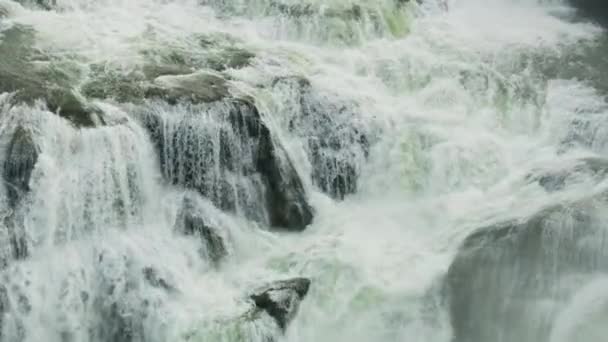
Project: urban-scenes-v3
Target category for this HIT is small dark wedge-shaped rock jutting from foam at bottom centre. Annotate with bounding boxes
[251,278,310,330]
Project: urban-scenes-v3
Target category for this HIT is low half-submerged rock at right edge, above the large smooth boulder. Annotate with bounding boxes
[526,157,608,191]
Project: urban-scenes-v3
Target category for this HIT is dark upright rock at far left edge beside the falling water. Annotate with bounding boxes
[2,126,39,208]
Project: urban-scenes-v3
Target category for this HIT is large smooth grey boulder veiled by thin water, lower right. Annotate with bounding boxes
[445,195,608,342]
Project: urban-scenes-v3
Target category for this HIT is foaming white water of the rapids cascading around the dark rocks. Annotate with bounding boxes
[0,0,608,342]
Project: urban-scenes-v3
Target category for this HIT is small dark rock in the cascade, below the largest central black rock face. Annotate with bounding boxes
[175,197,228,264]
